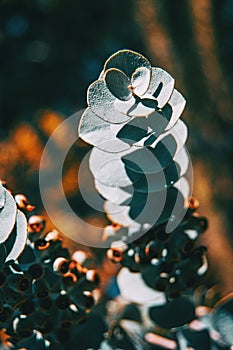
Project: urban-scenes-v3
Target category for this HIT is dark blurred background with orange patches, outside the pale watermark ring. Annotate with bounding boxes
[0,0,233,294]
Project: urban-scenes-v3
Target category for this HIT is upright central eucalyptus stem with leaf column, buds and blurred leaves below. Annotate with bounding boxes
[79,50,233,350]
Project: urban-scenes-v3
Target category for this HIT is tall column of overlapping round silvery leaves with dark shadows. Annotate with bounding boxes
[79,50,192,237]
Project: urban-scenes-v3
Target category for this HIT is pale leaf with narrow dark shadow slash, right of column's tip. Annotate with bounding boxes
[147,67,175,108]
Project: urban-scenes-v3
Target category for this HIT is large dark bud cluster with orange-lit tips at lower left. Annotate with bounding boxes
[0,186,99,349]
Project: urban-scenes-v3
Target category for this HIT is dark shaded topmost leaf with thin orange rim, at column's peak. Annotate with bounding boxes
[104,50,151,79]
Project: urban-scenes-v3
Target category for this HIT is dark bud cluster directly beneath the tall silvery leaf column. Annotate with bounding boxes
[106,198,208,299]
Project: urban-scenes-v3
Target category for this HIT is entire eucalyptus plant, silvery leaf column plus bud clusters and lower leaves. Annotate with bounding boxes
[0,50,233,350]
